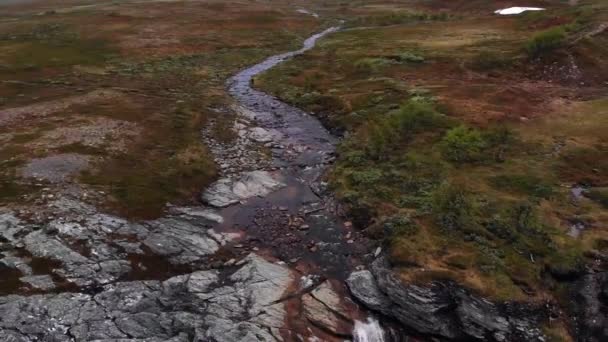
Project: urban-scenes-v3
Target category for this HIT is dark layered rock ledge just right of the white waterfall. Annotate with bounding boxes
[347,258,543,341]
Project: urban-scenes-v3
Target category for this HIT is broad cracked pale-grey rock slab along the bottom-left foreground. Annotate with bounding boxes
[0,254,293,342]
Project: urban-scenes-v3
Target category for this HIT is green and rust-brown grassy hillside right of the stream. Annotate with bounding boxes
[256,1,608,312]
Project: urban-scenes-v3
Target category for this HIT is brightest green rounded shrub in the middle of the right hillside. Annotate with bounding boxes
[441,125,487,163]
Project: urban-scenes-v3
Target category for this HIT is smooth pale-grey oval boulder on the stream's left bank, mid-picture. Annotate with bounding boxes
[202,171,285,208]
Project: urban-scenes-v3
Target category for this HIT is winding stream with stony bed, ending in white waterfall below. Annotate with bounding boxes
[216,27,384,342]
